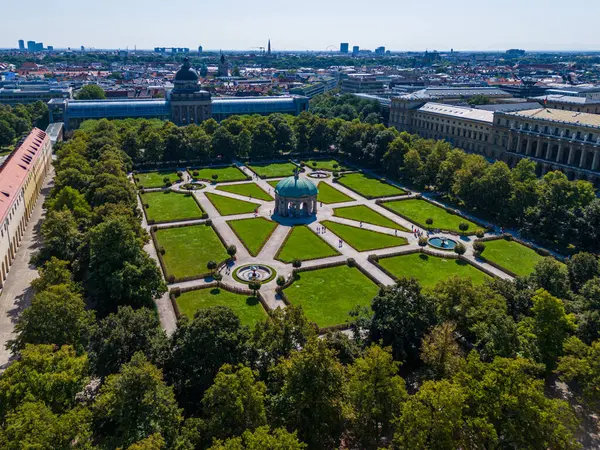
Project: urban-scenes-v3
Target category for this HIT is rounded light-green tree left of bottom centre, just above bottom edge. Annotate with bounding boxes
[202,364,267,439]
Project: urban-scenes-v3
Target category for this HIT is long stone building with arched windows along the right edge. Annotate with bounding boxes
[390,99,600,187]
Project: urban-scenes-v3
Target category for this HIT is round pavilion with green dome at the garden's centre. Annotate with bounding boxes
[275,171,319,217]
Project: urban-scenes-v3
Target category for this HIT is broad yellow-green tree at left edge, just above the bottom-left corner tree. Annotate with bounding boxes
[0,345,88,418]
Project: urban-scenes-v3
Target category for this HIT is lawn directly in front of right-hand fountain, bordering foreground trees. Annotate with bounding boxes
[379,253,489,288]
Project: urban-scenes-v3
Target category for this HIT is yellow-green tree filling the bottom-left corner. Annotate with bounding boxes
[0,401,95,450]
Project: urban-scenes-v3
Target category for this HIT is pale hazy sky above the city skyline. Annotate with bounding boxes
[0,0,600,50]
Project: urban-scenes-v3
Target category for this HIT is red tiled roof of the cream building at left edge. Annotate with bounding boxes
[0,128,50,223]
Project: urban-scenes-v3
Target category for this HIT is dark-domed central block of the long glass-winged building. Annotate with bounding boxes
[169,58,212,125]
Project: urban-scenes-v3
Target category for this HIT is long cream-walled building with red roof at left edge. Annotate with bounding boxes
[0,128,52,288]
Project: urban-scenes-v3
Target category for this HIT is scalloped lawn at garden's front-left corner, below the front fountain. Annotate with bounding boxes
[177,288,267,327]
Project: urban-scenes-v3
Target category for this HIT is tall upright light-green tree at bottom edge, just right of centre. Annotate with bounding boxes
[348,345,407,449]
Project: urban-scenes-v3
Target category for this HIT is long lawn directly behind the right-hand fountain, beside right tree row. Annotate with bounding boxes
[384,198,479,233]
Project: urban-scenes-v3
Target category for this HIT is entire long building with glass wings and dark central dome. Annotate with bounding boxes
[48,58,308,130]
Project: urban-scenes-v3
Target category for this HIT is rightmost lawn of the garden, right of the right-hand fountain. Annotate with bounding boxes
[482,239,544,277]
